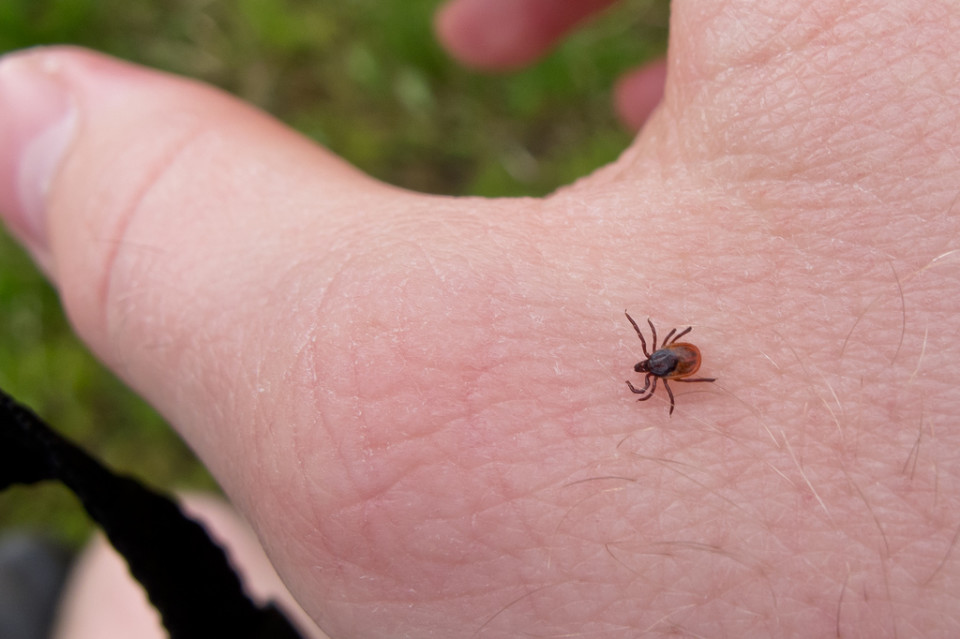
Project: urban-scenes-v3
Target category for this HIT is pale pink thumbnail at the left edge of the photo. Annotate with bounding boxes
[0,49,77,247]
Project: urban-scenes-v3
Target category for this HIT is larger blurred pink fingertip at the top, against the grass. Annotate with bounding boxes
[436,0,615,70]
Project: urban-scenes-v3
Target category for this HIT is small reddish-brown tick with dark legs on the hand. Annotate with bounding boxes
[623,311,717,415]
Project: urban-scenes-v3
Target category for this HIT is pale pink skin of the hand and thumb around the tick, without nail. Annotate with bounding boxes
[5,0,960,639]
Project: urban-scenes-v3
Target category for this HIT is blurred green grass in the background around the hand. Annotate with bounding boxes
[0,0,668,544]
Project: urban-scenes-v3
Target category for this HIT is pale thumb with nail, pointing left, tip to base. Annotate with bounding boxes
[0,48,402,464]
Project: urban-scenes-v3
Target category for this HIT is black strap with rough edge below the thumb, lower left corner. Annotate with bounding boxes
[0,390,301,639]
